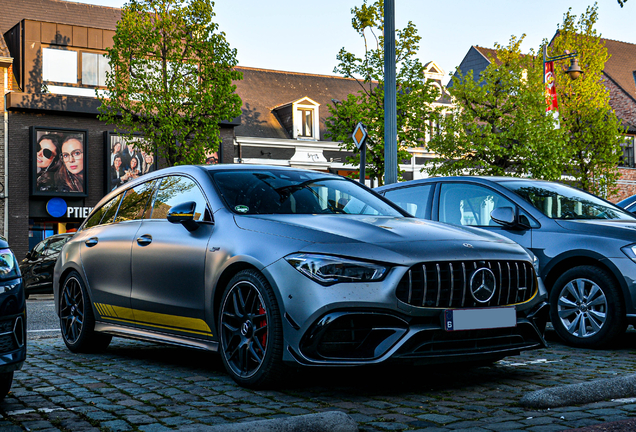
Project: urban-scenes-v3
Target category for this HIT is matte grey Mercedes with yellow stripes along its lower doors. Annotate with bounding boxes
[54,165,547,387]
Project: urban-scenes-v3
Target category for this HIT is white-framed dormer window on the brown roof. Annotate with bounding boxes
[273,97,320,140]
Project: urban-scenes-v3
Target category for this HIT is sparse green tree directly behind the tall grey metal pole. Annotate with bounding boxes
[326,0,439,184]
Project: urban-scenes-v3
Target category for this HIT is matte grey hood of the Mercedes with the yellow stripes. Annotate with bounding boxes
[235,215,530,263]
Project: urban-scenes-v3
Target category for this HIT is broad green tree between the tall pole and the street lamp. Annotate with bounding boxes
[426,35,566,179]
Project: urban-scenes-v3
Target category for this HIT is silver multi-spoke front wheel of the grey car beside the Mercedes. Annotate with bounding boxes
[550,266,626,348]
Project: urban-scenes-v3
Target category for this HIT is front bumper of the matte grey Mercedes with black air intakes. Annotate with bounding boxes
[266,260,548,366]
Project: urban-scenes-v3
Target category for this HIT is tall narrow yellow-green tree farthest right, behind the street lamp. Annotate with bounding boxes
[550,4,624,196]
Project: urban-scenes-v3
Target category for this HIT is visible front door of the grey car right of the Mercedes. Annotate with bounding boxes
[434,182,536,249]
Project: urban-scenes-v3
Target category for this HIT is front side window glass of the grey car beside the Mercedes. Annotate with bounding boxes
[439,183,516,226]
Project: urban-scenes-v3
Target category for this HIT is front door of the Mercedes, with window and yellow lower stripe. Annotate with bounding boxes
[131,175,214,337]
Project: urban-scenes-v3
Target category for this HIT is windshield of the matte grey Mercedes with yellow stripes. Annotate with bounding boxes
[210,170,403,216]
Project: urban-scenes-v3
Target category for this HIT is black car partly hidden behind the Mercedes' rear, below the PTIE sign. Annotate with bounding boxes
[20,233,73,298]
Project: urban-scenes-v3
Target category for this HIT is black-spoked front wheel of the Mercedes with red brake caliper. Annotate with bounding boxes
[219,270,284,388]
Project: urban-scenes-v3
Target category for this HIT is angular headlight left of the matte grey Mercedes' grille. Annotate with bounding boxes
[285,254,388,285]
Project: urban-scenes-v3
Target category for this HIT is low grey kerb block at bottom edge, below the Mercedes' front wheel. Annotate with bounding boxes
[181,411,358,432]
